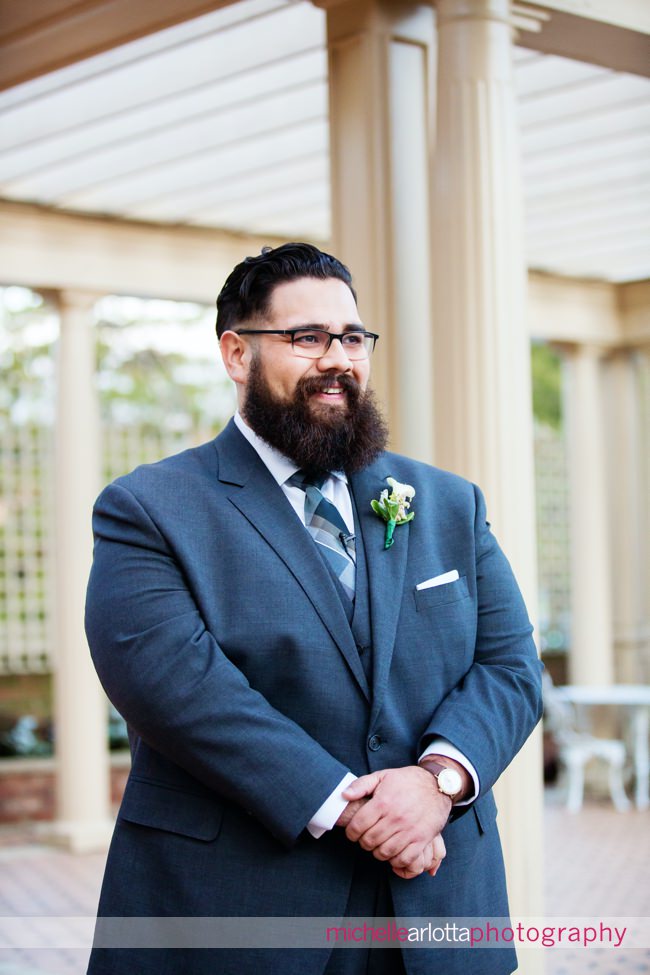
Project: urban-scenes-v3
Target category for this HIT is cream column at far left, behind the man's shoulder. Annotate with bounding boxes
[54,291,111,852]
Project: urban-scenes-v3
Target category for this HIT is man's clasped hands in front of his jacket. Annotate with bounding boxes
[336,765,452,880]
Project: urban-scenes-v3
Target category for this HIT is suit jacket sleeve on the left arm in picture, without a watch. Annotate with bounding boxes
[86,483,348,845]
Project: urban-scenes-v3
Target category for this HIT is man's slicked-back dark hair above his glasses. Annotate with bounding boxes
[217,244,357,338]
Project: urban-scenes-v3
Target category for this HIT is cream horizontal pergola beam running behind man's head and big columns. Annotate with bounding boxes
[0,200,650,348]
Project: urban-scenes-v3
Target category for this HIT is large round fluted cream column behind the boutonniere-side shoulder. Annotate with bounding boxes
[433,0,542,944]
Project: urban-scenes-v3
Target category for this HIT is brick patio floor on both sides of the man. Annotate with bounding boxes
[0,793,650,975]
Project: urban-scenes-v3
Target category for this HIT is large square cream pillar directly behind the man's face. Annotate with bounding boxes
[321,0,434,462]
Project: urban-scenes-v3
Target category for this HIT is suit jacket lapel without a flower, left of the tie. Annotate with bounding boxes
[215,421,370,699]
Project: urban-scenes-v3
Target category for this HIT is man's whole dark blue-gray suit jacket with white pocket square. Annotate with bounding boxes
[86,422,541,975]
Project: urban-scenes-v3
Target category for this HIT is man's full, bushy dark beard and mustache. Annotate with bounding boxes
[242,356,388,474]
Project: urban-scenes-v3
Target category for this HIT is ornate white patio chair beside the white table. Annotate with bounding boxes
[543,674,630,812]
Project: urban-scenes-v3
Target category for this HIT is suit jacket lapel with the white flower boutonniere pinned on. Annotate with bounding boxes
[350,458,411,720]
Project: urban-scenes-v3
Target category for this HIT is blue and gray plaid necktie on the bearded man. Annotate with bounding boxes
[287,471,356,601]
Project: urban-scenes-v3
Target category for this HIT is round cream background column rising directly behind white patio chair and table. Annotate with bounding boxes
[565,345,614,684]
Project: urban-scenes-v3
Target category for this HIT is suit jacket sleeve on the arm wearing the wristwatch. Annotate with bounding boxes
[420,487,543,795]
